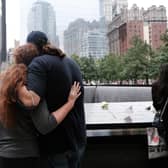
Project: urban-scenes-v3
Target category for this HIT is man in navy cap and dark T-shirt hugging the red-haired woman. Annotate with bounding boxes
[19,31,86,168]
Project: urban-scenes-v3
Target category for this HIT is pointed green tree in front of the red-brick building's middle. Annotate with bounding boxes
[123,36,150,84]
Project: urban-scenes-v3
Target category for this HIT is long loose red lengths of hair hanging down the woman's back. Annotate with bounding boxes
[0,64,27,127]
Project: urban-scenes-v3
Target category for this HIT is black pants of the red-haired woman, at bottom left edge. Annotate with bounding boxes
[0,157,47,168]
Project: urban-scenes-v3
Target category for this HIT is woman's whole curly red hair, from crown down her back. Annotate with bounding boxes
[0,43,39,127]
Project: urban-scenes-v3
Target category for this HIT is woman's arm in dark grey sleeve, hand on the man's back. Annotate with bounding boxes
[31,82,81,135]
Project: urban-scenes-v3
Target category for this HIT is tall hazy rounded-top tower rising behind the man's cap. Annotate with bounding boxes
[27,1,58,45]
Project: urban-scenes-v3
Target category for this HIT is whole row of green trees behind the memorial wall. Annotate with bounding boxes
[72,31,168,84]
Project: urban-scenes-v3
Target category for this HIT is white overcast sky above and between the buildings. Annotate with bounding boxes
[6,0,168,48]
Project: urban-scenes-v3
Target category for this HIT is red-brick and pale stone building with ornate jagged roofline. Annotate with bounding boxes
[108,4,167,54]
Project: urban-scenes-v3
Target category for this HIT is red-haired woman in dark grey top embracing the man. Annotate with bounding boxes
[0,44,81,168]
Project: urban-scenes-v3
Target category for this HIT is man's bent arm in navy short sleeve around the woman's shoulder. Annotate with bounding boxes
[17,57,48,107]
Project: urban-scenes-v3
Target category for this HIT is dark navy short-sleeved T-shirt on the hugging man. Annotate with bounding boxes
[27,55,86,154]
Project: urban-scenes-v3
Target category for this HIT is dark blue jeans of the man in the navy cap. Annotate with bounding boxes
[48,147,85,168]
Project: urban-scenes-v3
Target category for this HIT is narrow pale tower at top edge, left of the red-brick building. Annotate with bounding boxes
[99,0,112,22]
